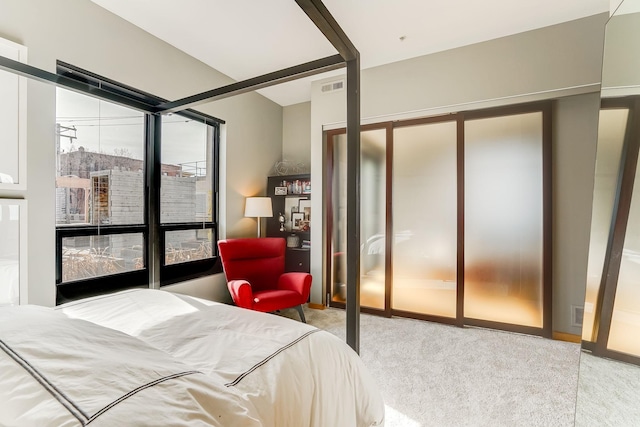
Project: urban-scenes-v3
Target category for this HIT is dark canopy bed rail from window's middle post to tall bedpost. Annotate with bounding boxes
[155,55,345,113]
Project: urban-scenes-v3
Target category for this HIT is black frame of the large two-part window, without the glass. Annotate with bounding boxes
[55,61,225,304]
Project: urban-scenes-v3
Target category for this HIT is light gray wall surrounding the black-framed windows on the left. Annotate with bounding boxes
[0,0,282,305]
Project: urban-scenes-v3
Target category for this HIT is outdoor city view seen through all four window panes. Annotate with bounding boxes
[56,89,213,282]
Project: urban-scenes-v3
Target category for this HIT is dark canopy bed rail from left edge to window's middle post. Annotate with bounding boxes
[0,56,154,112]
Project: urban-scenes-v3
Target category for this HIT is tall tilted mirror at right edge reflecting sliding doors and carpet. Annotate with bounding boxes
[575,0,640,427]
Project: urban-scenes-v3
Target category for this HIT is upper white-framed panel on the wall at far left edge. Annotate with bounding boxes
[0,38,27,190]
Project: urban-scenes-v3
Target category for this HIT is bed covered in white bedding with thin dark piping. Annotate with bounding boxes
[0,289,384,427]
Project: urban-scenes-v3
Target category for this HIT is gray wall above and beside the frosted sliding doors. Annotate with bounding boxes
[304,13,608,333]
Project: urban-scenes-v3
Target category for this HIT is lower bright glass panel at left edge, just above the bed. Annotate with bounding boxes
[0,200,20,306]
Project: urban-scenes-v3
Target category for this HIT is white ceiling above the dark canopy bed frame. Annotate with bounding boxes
[92,0,610,106]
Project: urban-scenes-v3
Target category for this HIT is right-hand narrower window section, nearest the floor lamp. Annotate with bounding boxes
[160,114,217,284]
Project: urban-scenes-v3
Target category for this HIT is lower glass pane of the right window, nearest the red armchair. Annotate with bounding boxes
[164,229,213,265]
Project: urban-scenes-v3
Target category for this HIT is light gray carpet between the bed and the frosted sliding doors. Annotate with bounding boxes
[281,308,580,427]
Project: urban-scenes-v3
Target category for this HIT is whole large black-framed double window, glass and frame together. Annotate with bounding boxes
[55,64,219,302]
